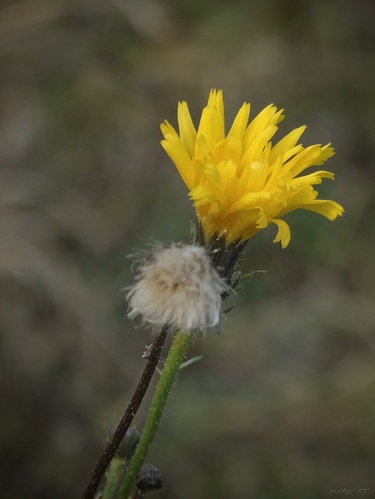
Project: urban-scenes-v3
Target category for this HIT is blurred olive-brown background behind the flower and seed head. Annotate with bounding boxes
[0,0,375,499]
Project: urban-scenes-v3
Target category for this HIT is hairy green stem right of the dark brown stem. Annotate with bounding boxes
[117,333,193,499]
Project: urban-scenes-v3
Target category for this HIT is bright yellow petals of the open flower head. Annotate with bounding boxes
[161,90,344,248]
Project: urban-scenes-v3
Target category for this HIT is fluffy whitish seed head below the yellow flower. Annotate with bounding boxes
[126,244,229,332]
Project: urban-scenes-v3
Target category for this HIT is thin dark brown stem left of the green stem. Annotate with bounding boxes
[81,326,168,499]
